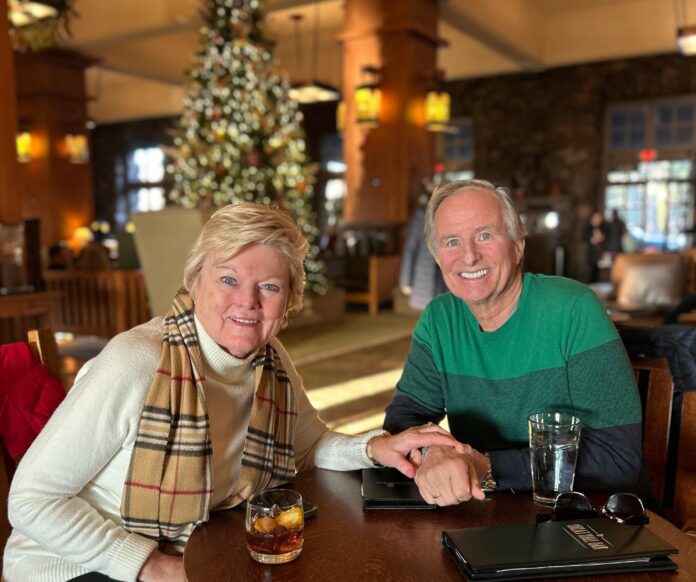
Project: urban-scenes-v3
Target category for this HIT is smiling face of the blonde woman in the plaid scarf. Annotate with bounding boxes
[194,244,290,358]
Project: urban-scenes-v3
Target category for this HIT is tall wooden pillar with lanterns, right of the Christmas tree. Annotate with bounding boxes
[341,0,438,224]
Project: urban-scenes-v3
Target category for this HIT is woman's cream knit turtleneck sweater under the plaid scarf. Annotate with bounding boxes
[2,318,382,582]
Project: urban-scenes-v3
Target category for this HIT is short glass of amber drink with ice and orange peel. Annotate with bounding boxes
[246,489,304,564]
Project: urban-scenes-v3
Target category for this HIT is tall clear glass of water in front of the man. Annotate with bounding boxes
[528,412,581,507]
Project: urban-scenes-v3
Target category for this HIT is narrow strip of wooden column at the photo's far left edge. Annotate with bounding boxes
[0,0,22,223]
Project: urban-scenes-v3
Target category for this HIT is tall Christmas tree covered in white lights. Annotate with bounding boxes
[167,0,326,293]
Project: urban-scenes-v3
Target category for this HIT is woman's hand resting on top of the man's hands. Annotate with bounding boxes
[371,422,464,478]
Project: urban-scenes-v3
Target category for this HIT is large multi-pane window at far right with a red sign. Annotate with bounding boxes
[604,96,696,250]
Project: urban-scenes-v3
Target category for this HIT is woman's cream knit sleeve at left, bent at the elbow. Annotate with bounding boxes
[4,324,159,582]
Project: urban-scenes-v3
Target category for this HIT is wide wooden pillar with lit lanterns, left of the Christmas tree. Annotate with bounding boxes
[15,49,94,247]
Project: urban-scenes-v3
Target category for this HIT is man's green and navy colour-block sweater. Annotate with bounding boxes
[384,273,641,490]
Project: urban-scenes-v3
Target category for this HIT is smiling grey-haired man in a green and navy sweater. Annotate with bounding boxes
[384,180,641,505]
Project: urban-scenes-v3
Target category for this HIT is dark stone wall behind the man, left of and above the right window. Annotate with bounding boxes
[448,54,696,279]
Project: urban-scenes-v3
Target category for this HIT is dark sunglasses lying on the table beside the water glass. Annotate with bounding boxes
[537,491,650,525]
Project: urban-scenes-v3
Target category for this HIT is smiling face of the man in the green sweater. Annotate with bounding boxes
[434,189,524,310]
